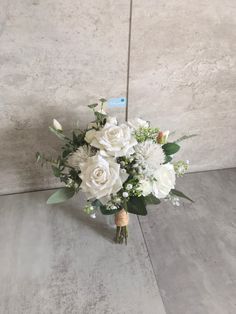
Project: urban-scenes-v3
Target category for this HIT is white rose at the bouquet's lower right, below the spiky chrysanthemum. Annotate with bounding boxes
[152,164,175,198]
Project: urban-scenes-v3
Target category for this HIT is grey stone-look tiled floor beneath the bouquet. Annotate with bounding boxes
[0,169,236,314]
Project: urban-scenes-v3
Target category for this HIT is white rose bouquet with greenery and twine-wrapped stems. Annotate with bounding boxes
[36,99,193,244]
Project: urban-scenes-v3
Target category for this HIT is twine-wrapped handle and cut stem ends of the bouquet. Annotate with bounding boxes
[115,208,129,244]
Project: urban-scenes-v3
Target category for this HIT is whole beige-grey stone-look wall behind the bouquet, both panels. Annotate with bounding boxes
[0,0,236,193]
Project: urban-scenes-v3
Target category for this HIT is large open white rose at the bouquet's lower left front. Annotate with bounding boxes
[80,154,122,199]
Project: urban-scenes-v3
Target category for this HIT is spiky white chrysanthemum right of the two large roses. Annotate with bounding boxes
[135,140,165,171]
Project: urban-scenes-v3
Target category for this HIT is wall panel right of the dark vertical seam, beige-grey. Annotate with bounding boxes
[129,0,236,171]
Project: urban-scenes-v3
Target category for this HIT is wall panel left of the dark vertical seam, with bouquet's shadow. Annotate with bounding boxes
[0,0,129,193]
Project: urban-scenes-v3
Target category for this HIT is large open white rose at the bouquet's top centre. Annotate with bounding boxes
[91,123,137,157]
